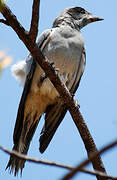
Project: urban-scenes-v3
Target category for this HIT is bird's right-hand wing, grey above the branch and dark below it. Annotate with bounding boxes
[39,49,86,153]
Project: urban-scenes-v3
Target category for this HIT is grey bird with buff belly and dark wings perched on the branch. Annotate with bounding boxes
[6,6,103,176]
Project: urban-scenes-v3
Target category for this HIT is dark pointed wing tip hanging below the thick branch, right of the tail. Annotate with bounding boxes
[39,103,67,153]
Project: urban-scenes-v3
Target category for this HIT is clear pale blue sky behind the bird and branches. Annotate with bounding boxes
[0,0,117,180]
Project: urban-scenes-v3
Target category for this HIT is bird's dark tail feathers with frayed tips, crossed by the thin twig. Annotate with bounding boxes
[6,115,39,176]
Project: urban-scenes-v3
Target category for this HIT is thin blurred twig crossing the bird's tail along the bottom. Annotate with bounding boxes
[0,146,117,180]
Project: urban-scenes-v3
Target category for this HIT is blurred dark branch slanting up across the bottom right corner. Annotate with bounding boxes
[62,140,117,180]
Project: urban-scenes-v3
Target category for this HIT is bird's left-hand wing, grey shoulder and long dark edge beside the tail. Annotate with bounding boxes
[13,30,51,143]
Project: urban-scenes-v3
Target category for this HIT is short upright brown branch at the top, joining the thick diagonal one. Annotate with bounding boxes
[29,0,40,42]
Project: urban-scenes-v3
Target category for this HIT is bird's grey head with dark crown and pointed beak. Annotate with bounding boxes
[53,7,103,29]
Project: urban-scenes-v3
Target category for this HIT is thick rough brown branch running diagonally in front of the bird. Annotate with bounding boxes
[0,0,107,180]
